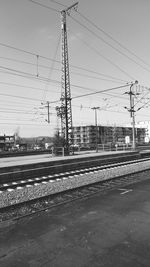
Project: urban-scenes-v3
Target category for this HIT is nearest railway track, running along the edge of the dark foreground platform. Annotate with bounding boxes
[0,170,150,222]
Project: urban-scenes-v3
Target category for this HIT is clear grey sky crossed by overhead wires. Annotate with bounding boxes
[0,0,150,137]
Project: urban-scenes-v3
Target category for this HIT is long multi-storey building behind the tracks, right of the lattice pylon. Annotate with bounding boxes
[73,125,146,148]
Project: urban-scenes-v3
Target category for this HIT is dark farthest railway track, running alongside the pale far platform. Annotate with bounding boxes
[0,152,141,184]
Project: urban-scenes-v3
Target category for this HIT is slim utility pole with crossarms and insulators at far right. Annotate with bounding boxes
[125,81,138,150]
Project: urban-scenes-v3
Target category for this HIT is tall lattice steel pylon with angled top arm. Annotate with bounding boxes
[61,2,78,154]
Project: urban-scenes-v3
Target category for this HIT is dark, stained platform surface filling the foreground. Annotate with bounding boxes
[0,177,150,267]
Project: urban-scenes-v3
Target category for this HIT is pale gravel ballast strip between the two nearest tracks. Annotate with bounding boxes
[0,160,150,208]
